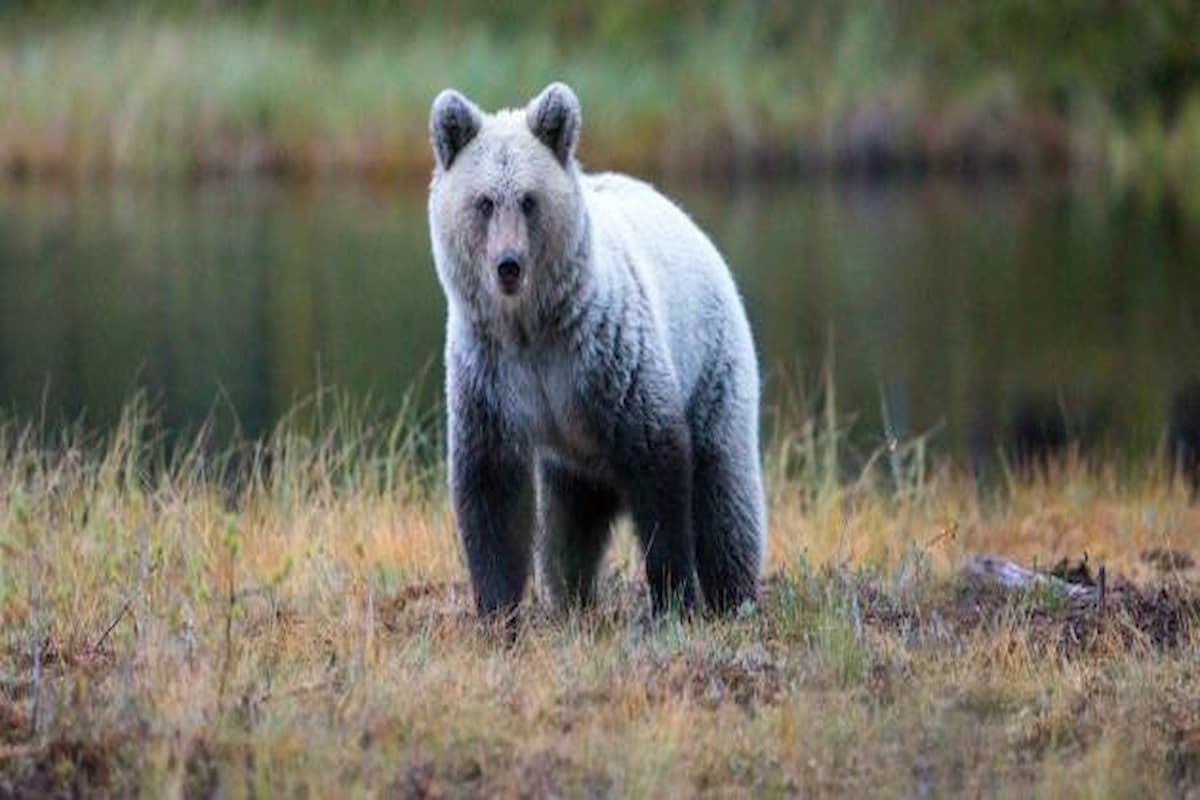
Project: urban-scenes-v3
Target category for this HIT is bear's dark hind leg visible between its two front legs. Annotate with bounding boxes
[538,461,620,610]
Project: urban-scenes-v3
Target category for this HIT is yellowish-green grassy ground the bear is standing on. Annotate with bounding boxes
[0,407,1200,796]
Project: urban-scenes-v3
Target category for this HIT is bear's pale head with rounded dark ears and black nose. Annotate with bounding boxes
[430,83,587,328]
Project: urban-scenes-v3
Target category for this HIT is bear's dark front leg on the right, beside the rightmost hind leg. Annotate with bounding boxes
[619,414,696,614]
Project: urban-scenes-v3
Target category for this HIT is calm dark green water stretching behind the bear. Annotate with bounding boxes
[0,182,1200,456]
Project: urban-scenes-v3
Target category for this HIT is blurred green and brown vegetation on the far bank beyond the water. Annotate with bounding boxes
[0,0,1200,180]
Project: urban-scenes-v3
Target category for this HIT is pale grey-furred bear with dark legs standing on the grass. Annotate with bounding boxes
[428,83,767,621]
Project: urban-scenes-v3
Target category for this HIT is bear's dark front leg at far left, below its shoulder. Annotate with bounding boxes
[449,357,535,624]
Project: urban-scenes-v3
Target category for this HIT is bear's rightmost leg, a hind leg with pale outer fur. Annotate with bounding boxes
[692,407,766,614]
